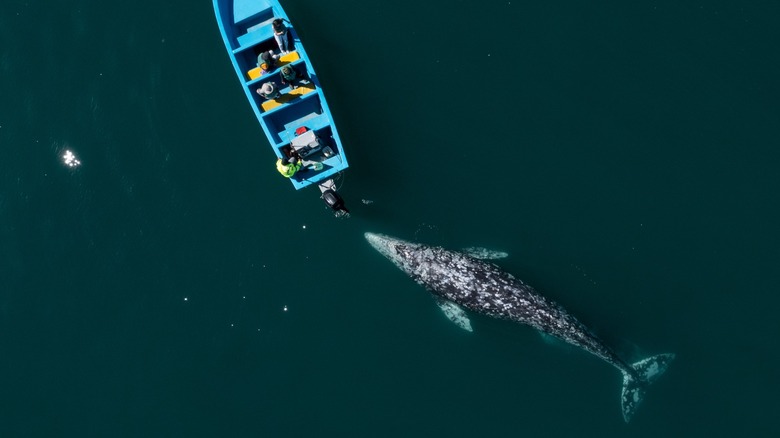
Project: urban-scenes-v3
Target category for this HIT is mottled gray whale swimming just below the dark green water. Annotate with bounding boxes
[365,233,674,422]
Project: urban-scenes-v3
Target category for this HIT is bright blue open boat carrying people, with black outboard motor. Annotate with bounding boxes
[213,0,348,215]
